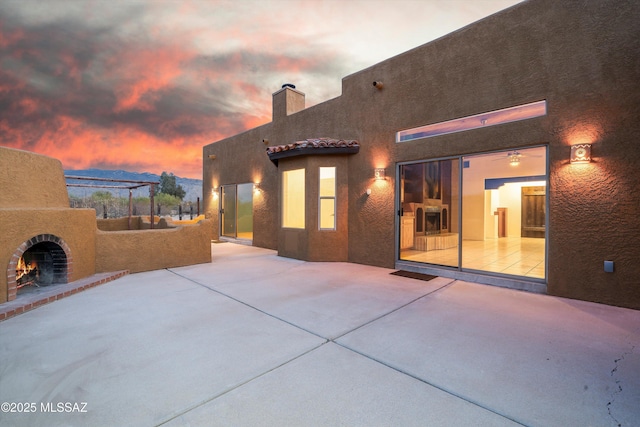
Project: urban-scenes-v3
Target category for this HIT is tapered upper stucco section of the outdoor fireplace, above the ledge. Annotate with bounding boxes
[0,147,69,209]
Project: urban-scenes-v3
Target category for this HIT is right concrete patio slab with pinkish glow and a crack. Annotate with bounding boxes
[337,281,640,426]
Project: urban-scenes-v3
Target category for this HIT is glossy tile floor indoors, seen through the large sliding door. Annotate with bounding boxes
[400,237,545,279]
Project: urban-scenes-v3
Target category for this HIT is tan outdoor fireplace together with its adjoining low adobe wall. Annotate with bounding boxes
[0,147,213,308]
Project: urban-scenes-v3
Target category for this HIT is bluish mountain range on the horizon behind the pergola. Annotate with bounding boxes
[64,169,202,203]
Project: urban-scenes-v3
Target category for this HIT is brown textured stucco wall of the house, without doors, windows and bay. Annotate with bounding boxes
[204,0,640,308]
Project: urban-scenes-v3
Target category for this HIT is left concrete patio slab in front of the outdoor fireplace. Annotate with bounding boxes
[0,270,324,426]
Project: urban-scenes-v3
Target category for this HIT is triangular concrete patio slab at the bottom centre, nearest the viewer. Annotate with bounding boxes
[166,343,519,427]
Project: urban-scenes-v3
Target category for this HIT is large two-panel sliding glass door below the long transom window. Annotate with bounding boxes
[399,147,547,279]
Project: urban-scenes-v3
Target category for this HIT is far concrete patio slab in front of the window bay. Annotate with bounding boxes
[175,244,453,339]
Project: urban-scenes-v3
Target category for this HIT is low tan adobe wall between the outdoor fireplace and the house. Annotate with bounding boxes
[95,220,212,273]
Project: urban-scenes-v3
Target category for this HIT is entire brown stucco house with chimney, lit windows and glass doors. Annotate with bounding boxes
[203,0,640,309]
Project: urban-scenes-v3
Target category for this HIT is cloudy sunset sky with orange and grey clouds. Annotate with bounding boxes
[0,0,519,179]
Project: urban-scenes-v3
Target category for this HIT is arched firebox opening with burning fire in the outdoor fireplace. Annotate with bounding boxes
[16,242,67,293]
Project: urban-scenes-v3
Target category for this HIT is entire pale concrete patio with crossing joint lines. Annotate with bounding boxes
[0,243,640,426]
